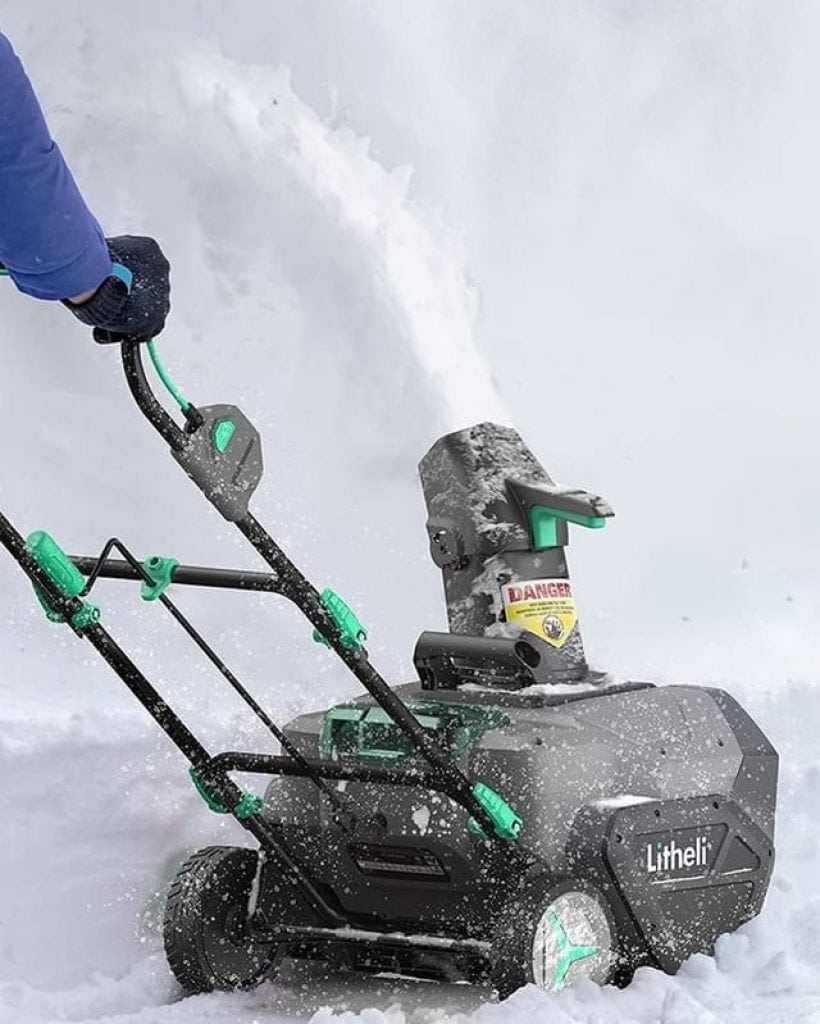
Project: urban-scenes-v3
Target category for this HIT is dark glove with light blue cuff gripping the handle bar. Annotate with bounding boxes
[63,234,171,345]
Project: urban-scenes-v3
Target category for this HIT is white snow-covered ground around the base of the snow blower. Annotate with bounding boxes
[0,686,820,1024]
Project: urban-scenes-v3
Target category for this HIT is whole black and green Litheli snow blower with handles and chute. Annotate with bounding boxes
[0,343,778,996]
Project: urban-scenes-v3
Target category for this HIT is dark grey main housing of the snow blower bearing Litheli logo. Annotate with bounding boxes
[259,684,777,975]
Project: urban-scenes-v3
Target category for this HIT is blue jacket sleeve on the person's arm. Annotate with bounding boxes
[0,34,112,299]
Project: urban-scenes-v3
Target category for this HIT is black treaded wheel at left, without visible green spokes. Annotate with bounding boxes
[163,846,276,994]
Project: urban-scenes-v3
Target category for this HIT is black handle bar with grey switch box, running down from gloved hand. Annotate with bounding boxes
[121,342,522,842]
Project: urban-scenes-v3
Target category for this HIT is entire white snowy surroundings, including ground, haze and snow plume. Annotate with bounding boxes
[0,0,820,1024]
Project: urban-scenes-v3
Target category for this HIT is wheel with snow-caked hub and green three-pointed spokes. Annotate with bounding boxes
[490,878,617,999]
